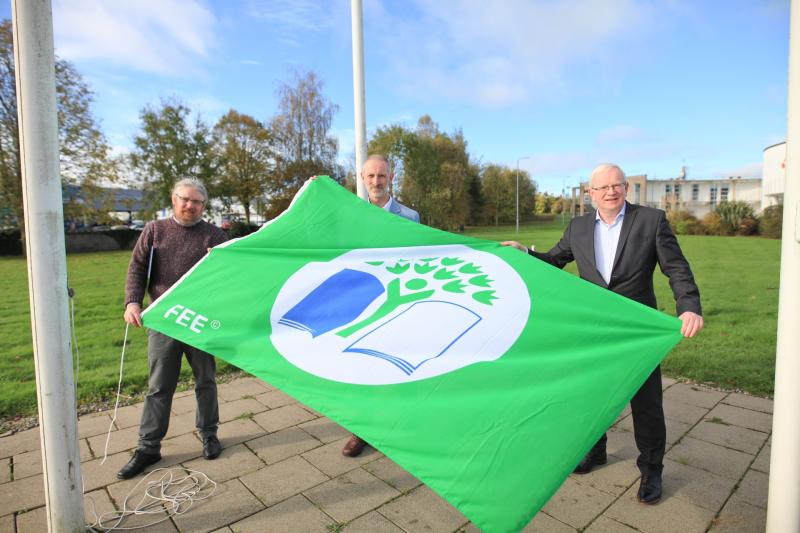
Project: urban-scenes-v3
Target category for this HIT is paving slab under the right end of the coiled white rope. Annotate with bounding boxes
[172,479,264,533]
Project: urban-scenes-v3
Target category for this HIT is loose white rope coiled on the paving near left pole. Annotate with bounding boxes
[89,468,217,532]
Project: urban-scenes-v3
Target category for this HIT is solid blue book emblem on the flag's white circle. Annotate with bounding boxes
[278,268,384,337]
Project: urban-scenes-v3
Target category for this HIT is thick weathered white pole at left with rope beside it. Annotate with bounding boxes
[12,0,86,532]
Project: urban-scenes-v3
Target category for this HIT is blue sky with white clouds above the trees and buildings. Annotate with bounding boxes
[0,0,789,192]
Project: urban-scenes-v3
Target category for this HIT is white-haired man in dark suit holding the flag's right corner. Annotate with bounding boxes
[503,164,703,504]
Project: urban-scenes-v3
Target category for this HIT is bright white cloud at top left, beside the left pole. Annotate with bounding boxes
[53,0,216,75]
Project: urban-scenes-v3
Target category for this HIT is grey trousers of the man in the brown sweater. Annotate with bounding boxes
[138,330,219,453]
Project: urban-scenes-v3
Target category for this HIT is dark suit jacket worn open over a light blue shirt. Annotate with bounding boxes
[531,204,701,316]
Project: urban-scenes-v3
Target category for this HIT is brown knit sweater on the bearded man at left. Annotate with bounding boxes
[125,218,228,305]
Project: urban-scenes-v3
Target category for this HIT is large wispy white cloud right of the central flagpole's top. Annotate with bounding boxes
[365,0,653,107]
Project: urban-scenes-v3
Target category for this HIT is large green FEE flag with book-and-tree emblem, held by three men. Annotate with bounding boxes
[144,177,681,532]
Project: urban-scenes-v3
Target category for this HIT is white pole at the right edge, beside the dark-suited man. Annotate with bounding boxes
[767,0,800,533]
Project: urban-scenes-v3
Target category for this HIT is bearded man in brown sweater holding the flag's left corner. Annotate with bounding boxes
[117,179,228,479]
